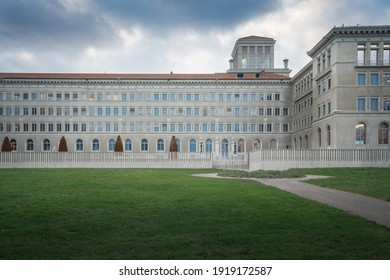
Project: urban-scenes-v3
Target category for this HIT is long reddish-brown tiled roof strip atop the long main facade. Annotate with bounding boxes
[0,72,290,80]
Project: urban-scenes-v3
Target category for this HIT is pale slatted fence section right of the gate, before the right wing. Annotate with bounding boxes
[248,149,390,171]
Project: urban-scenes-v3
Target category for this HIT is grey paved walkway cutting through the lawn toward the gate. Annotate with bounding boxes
[196,173,390,228]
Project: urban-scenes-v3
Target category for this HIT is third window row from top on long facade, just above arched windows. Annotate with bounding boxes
[0,122,289,133]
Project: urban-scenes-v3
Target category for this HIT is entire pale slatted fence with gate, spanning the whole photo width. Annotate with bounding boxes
[0,149,390,171]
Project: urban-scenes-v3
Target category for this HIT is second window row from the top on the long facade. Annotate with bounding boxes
[0,106,289,117]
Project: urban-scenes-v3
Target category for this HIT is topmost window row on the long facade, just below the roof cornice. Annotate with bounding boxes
[0,92,281,102]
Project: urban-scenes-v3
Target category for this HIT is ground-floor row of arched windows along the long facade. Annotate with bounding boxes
[2,138,277,154]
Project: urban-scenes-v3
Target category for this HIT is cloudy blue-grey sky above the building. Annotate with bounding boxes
[0,0,390,73]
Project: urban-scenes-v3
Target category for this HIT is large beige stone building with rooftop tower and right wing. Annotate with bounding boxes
[0,26,390,155]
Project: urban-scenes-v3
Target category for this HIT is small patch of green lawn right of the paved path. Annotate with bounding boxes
[303,168,390,201]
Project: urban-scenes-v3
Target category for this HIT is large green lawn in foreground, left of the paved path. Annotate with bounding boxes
[0,169,390,259]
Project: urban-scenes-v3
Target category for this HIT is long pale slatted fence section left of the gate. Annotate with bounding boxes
[0,152,212,168]
